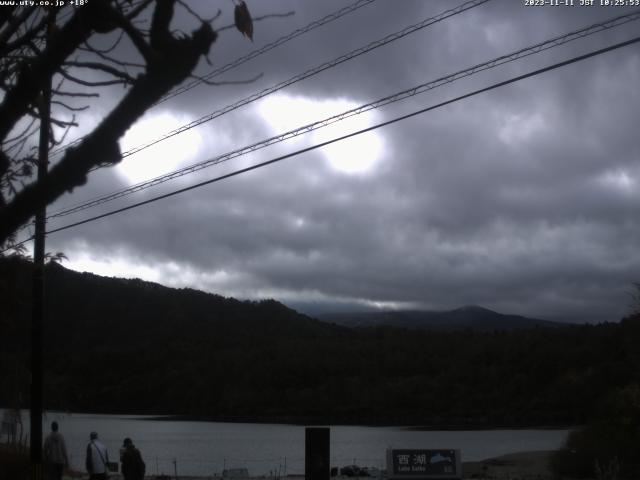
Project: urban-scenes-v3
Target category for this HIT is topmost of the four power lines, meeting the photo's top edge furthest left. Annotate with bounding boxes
[51,0,376,155]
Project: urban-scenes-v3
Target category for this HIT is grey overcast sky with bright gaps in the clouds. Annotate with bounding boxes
[31,0,640,322]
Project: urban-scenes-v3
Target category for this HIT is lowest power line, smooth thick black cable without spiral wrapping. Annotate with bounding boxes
[32,36,640,244]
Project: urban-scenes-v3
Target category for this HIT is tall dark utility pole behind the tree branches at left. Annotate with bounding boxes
[30,10,55,480]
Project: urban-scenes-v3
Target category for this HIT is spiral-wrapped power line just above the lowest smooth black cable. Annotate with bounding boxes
[48,10,640,219]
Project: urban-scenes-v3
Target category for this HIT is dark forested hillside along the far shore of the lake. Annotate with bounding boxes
[0,260,640,427]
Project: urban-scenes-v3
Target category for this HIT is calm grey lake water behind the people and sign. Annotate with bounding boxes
[2,412,567,475]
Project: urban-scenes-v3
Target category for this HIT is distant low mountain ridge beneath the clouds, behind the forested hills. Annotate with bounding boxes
[317,305,567,331]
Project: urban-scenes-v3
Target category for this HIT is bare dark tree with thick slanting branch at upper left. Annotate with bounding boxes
[0,0,255,246]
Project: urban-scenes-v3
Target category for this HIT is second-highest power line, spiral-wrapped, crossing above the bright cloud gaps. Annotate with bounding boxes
[48,0,490,162]
